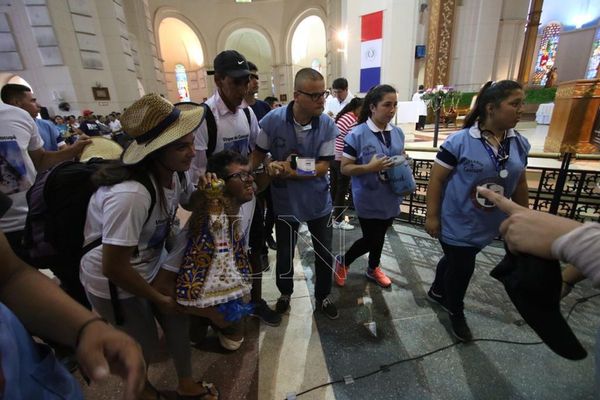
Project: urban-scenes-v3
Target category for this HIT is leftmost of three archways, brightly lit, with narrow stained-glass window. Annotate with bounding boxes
[158,17,208,103]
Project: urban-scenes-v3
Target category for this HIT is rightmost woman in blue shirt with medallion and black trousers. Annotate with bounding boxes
[425,80,530,341]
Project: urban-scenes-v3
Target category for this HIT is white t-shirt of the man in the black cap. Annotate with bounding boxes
[190,91,259,182]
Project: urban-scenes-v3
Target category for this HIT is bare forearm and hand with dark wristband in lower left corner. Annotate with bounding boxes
[0,233,146,400]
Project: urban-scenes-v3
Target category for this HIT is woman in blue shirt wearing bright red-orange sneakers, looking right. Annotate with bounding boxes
[334,85,404,288]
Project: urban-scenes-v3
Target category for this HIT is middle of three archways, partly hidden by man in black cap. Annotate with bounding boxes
[225,28,273,99]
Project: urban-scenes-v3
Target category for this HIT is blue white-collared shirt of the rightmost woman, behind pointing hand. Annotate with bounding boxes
[435,126,531,248]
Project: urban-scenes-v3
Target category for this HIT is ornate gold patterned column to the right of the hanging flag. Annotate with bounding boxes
[425,0,456,87]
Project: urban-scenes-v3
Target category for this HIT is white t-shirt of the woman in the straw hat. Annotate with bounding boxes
[80,174,194,299]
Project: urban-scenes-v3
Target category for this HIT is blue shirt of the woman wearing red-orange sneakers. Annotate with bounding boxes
[343,119,404,219]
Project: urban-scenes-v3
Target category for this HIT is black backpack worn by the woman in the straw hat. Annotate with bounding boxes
[24,158,156,269]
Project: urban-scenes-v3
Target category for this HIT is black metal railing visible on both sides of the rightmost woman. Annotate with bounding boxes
[398,148,600,225]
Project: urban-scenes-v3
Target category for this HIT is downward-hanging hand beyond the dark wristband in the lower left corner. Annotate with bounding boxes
[77,321,146,400]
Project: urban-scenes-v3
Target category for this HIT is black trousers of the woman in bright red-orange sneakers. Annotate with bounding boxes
[342,217,394,269]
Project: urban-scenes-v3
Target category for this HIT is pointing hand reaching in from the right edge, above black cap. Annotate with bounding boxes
[477,187,581,259]
